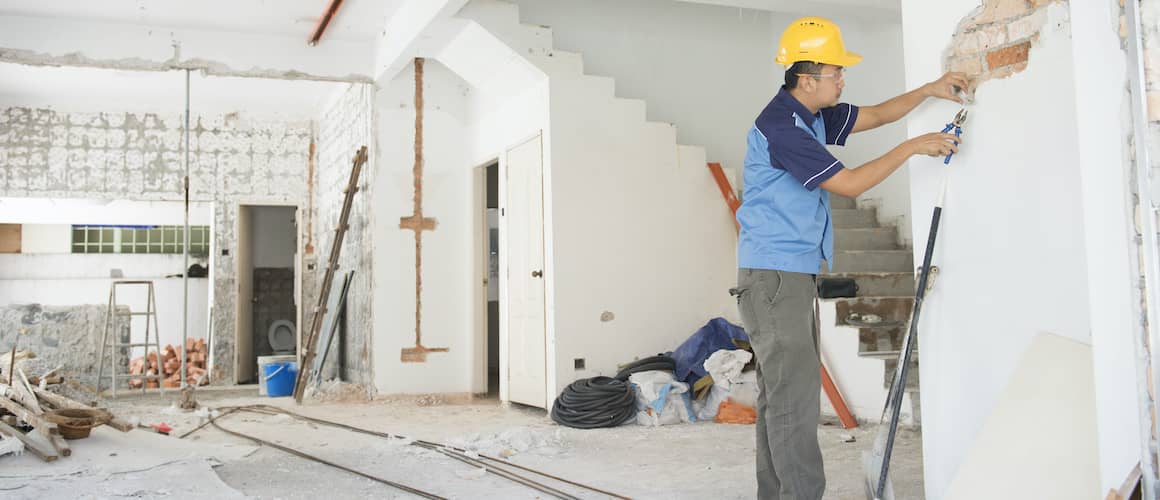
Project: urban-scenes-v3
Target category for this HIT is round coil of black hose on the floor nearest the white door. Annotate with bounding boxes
[552,377,637,429]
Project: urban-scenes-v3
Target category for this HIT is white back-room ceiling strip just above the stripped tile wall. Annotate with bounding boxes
[0,63,348,119]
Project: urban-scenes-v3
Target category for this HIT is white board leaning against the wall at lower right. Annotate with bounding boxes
[945,333,1095,500]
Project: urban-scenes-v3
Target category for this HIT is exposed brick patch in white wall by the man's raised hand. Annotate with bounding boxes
[943,0,1065,94]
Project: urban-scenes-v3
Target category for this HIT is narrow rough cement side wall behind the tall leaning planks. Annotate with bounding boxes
[315,84,376,396]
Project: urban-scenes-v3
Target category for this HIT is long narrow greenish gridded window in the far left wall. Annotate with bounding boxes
[72,225,210,256]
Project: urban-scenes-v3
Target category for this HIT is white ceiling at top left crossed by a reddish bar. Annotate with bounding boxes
[0,0,404,42]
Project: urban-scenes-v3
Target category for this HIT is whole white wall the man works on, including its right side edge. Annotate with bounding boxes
[902,0,1138,499]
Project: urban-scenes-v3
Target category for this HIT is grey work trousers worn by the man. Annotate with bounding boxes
[735,268,826,500]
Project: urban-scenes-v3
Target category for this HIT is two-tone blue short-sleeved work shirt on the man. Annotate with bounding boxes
[737,87,858,274]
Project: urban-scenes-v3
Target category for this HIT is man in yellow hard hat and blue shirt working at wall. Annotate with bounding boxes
[734,17,967,500]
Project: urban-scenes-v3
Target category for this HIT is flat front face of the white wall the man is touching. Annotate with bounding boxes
[902,0,1090,500]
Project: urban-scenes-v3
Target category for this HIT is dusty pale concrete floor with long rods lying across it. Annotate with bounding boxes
[0,389,922,500]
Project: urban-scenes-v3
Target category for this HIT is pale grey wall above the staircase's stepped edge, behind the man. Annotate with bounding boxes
[516,0,911,241]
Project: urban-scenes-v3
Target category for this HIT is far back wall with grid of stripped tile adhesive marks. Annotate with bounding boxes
[0,107,311,383]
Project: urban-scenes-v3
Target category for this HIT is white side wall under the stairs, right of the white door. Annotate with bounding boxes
[545,71,737,392]
